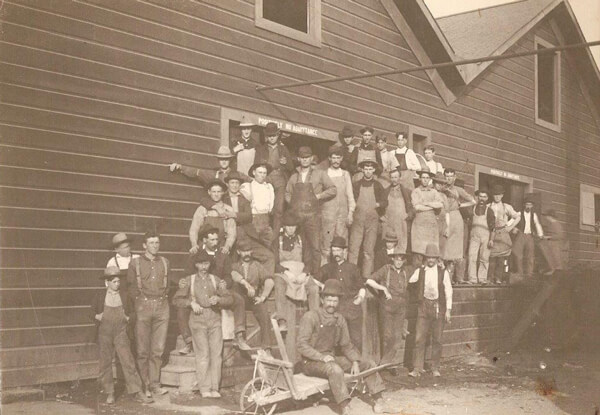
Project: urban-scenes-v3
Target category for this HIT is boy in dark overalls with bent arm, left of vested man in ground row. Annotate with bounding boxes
[365,248,408,372]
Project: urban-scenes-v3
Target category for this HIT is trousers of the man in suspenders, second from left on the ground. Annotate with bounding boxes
[135,297,169,388]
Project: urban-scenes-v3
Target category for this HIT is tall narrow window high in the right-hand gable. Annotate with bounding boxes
[535,38,560,131]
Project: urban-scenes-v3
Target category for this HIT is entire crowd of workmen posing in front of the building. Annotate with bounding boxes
[95,117,568,412]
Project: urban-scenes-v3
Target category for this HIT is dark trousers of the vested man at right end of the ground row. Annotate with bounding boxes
[413,298,445,370]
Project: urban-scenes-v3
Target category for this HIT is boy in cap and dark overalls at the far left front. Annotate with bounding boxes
[91,266,153,404]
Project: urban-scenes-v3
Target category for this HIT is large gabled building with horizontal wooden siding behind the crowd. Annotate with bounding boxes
[0,0,600,387]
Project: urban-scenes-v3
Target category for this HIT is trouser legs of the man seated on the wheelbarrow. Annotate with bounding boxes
[302,356,385,404]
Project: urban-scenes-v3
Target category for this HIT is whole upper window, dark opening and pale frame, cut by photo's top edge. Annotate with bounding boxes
[255,0,321,46]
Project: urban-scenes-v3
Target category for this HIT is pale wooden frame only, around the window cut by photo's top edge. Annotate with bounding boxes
[254,0,321,47]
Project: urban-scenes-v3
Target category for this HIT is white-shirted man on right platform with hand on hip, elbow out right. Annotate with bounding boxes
[488,184,521,284]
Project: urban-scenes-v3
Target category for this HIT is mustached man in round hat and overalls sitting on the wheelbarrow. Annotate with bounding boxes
[297,279,385,415]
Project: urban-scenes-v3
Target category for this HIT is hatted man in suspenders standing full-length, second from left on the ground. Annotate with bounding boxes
[127,231,169,397]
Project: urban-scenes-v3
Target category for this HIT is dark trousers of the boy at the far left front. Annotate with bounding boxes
[98,307,142,393]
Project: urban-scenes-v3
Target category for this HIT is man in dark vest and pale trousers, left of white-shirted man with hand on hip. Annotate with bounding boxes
[468,189,496,284]
